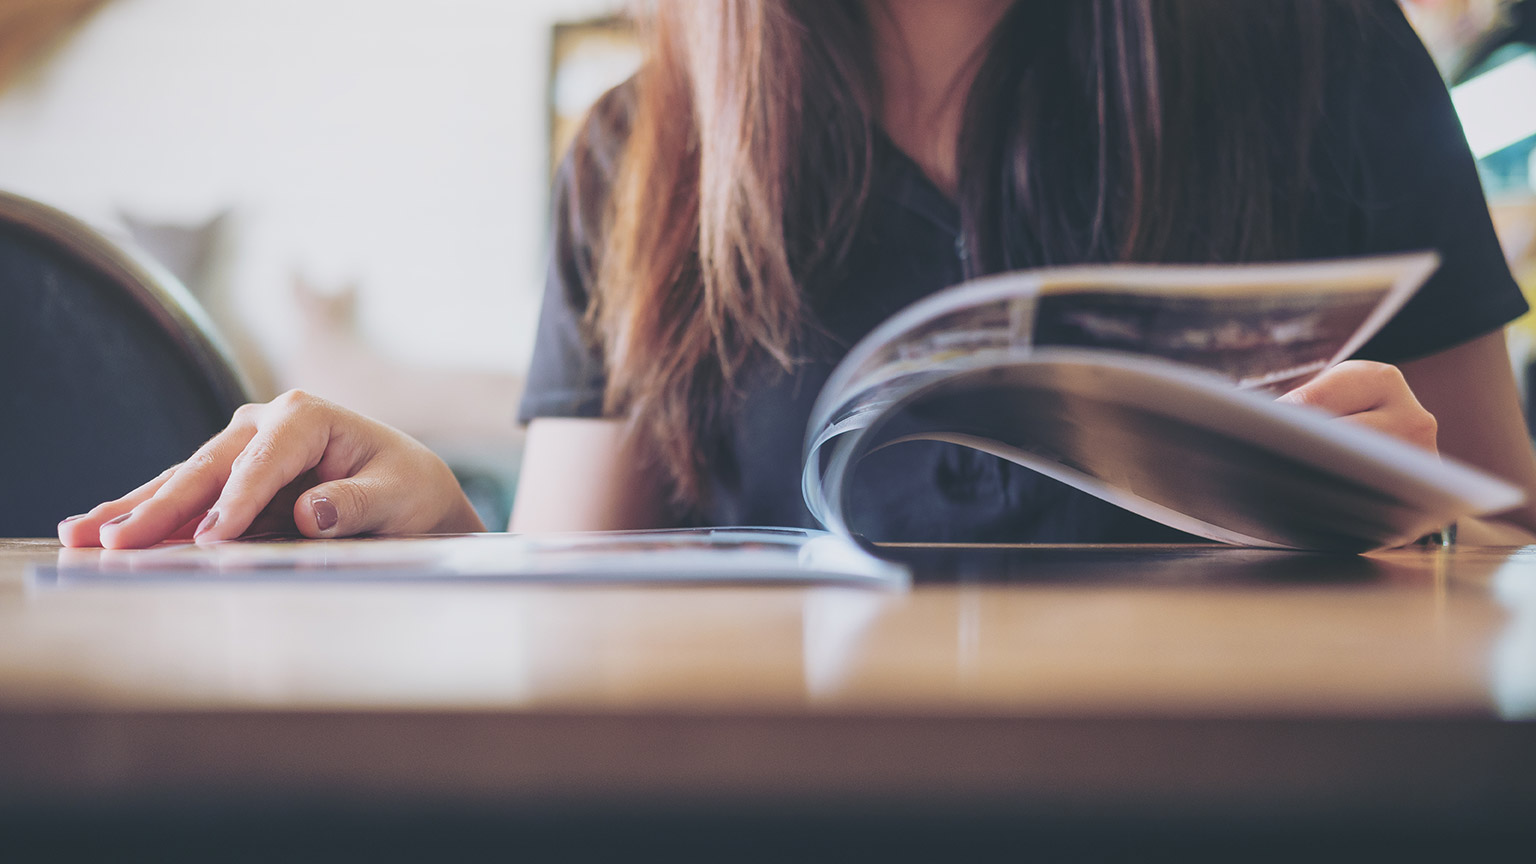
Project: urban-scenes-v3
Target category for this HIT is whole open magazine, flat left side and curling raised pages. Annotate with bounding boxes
[34,254,1522,587]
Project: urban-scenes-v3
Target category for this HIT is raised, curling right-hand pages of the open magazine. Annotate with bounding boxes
[802,252,1524,552]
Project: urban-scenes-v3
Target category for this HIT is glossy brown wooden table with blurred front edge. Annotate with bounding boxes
[0,541,1536,859]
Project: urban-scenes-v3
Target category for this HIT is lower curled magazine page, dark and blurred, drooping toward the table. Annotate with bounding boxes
[826,349,1522,552]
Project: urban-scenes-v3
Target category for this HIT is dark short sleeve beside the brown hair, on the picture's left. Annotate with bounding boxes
[518,83,633,423]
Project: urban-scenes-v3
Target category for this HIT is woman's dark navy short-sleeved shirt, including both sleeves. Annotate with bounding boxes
[519,3,1525,543]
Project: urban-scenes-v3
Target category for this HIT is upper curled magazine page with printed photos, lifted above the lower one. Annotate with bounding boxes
[802,252,1439,543]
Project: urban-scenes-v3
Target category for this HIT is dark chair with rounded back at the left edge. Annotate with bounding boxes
[0,192,246,537]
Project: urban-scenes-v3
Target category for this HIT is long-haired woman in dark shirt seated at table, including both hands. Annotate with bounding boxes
[60,0,1536,547]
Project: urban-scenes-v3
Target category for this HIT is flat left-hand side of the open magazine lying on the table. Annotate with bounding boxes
[31,527,911,589]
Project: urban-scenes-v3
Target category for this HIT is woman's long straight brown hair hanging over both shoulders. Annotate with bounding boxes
[576,0,1347,509]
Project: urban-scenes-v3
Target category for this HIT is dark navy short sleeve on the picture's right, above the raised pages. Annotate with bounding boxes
[1333,0,1527,363]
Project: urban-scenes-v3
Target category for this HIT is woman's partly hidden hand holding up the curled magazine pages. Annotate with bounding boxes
[1279,360,1439,454]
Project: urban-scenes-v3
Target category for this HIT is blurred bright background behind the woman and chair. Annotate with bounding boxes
[0,0,1536,526]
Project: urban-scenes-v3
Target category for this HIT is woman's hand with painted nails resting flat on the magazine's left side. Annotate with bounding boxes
[58,390,485,549]
